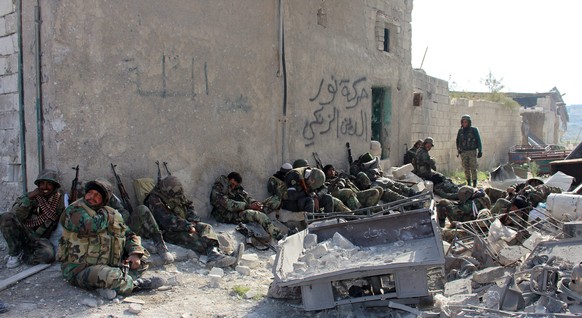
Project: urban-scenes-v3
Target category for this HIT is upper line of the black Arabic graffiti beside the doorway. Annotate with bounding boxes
[309,75,369,109]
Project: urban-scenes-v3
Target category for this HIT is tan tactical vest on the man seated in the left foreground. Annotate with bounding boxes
[57,201,127,266]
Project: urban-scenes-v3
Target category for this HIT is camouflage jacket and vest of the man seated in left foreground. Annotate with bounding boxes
[57,199,146,279]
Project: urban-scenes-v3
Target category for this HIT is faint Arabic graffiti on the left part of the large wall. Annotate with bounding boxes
[128,54,209,98]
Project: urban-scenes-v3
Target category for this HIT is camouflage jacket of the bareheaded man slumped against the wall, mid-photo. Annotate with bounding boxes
[210,175,257,217]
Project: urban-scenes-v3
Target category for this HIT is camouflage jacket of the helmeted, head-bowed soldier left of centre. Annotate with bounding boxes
[144,188,200,232]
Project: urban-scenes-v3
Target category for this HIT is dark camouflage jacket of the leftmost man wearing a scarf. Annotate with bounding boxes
[10,189,65,238]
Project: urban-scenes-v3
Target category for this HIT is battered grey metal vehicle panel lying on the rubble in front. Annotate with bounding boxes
[273,209,444,310]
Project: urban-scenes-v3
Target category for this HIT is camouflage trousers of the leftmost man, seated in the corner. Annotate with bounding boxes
[0,212,55,264]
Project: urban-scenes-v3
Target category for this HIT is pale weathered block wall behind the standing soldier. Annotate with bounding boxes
[408,71,521,172]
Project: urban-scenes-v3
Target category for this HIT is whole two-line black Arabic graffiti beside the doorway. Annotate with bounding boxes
[303,76,369,147]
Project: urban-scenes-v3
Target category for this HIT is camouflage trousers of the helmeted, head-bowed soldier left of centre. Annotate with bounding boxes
[164,222,219,255]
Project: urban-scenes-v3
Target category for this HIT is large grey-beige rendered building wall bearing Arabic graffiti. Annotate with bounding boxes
[1,0,412,216]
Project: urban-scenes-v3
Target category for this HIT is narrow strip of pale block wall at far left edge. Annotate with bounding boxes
[0,0,21,211]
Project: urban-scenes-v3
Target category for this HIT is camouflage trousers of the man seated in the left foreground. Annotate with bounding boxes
[61,262,148,295]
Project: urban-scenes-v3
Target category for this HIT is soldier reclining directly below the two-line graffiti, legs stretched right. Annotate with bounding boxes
[323,165,384,212]
